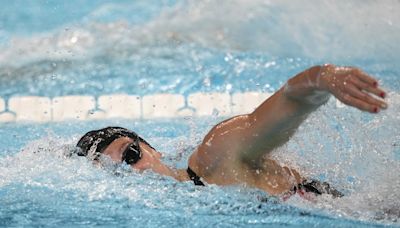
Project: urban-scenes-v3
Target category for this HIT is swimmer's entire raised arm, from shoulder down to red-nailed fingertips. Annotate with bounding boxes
[195,65,387,175]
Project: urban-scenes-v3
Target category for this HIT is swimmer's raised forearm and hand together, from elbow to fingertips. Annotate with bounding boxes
[242,65,387,165]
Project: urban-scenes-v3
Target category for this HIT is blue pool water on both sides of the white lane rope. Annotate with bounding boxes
[0,0,400,227]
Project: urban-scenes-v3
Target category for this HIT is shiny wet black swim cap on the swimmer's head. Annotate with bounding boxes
[76,127,154,160]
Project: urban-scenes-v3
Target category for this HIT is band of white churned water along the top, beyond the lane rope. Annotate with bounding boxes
[0,0,400,66]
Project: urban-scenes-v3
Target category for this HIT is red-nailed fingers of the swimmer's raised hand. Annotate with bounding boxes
[346,84,387,112]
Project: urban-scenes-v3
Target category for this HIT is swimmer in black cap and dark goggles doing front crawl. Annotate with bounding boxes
[77,64,387,200]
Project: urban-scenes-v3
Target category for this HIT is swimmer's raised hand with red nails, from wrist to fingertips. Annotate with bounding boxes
[316,64,387,113]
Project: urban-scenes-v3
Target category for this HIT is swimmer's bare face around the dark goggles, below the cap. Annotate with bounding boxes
[103,137,163,172]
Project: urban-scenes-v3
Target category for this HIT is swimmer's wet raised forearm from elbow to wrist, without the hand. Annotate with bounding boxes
[233,66,330,168]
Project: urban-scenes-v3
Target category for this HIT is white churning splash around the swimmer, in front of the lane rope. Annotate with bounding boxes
[0,92,400,224]
